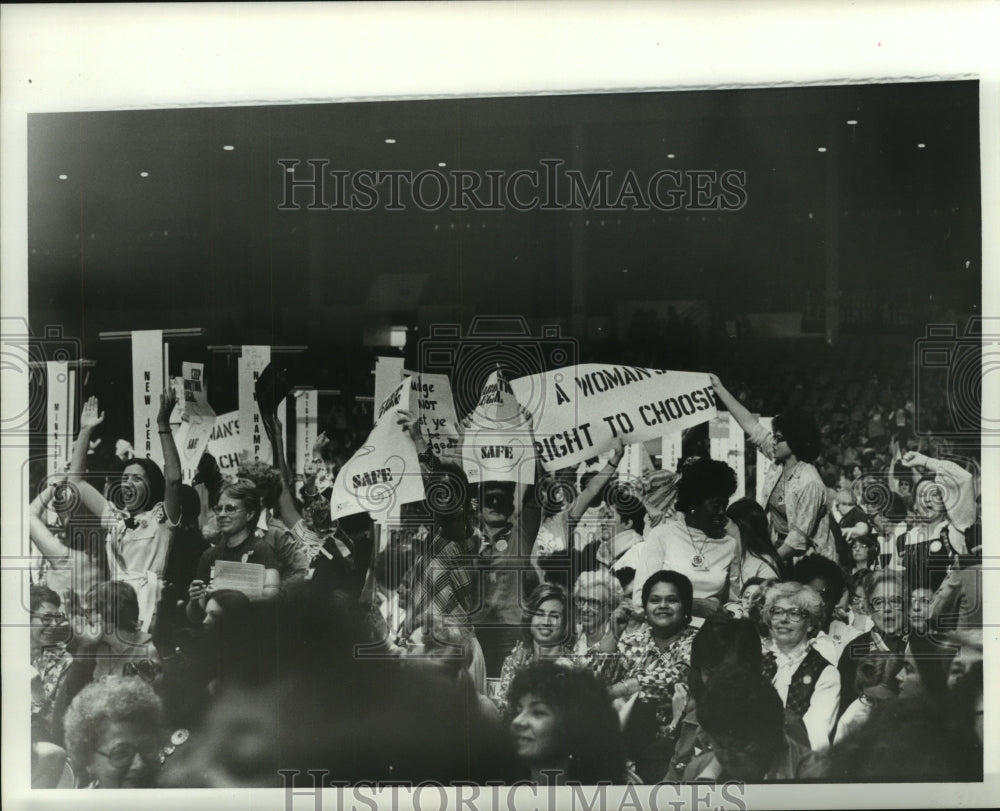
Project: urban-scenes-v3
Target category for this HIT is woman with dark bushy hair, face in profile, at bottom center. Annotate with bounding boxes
[507,662,626,786]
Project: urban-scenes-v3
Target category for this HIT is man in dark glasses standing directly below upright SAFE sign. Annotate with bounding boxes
[472,482,536,678]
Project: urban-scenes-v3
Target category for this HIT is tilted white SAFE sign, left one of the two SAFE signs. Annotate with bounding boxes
[330,377,424,520]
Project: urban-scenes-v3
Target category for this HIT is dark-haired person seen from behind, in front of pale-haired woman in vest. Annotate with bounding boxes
[683,671,823,783]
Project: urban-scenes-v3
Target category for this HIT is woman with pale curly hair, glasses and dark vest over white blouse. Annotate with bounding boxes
[763,583,840,752]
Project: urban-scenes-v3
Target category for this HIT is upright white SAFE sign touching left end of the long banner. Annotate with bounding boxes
[462,369,535,484]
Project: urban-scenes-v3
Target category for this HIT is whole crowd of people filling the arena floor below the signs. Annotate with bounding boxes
[30,358,983,788]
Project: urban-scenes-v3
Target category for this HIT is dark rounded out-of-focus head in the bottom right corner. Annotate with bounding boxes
[827,697,983,783]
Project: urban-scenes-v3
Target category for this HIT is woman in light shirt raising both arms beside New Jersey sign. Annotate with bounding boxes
[68,388,182,630]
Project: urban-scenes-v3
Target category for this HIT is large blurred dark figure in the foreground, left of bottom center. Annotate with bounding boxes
[158,591,514,788]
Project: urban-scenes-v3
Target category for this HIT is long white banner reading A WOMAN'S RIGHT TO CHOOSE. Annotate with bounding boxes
[510,363,716,470]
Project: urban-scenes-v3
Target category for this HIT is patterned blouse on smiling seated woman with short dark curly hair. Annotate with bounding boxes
[601,625,698,738]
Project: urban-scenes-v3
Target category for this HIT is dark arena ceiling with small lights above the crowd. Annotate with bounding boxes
[28,82,981,344]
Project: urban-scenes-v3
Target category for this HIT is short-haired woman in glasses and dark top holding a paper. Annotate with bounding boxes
[187,479,281,624]
